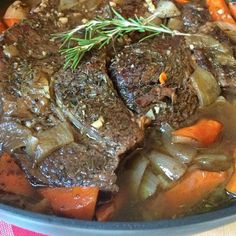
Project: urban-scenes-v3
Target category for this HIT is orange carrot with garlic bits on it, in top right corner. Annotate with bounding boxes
[207,0,236,24]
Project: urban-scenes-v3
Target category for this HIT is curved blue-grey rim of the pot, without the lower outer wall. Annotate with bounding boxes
[0,202,236,231]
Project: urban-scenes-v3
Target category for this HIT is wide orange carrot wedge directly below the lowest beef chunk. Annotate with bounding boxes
[40,187,99,220]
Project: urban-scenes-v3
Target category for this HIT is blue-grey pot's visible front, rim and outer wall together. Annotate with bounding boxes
[0,203,236,236]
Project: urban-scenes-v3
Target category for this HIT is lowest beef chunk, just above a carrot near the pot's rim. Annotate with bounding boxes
[15,136,119,191]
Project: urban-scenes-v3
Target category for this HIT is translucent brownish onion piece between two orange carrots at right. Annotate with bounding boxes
[194,154,232,171]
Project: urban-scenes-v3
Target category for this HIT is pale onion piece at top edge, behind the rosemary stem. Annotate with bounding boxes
[154,0,181,18]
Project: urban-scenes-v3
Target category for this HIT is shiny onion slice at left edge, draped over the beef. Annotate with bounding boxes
[0,122,38,152]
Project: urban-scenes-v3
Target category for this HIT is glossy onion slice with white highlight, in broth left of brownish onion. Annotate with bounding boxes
[148,150,186,181]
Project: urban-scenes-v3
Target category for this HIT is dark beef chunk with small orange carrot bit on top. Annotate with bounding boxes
[109,36,198,127]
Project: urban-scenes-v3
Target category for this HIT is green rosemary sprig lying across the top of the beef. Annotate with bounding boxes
[54,9,185,69]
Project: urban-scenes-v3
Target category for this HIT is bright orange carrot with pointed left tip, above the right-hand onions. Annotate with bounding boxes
[172,119,223,146]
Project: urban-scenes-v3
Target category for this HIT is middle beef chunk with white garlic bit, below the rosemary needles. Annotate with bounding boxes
[54,55,143,155]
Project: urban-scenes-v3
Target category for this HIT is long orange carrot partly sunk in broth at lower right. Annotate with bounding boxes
[147,170,228,218]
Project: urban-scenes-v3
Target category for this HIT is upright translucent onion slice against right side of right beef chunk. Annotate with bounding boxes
[191,66,221,107]
